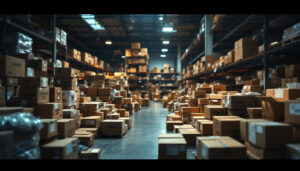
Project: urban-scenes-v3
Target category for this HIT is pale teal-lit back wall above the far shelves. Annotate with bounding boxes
[149,53,177,70]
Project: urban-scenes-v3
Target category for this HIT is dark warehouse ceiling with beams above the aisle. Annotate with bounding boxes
[57,14,203,62]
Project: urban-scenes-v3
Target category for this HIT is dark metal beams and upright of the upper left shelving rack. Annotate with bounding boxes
[0,15,104,73]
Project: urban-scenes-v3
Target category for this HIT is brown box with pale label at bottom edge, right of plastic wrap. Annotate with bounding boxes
[40,138,78,159]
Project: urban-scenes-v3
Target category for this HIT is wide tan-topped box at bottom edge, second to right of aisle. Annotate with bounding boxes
[196,136,247,160]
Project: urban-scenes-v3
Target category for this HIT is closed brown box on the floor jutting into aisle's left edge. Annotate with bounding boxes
[100,119,125,136]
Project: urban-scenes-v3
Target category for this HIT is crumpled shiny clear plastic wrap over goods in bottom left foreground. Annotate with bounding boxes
[0,112,43,159]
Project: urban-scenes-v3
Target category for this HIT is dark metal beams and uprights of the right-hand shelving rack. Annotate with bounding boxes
[181,15,300,95]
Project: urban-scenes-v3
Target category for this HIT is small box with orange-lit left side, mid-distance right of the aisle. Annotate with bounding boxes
[204,105,227,120]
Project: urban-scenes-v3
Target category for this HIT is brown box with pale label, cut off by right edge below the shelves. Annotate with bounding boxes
[284,100,300,126]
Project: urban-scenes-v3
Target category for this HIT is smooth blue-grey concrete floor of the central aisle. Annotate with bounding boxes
[93,101,195,159]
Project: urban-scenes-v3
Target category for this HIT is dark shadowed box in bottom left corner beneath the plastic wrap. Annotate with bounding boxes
[0,130,15,159]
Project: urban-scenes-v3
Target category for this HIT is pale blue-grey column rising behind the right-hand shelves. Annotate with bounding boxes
[204,14,213,83]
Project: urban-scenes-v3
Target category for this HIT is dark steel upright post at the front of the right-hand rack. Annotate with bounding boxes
[263,15,269,94]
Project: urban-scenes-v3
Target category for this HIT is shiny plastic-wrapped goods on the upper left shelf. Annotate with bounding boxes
[2,32,33,54]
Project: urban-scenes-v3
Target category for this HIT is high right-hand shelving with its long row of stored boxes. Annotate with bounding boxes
[181,15,300,94]
